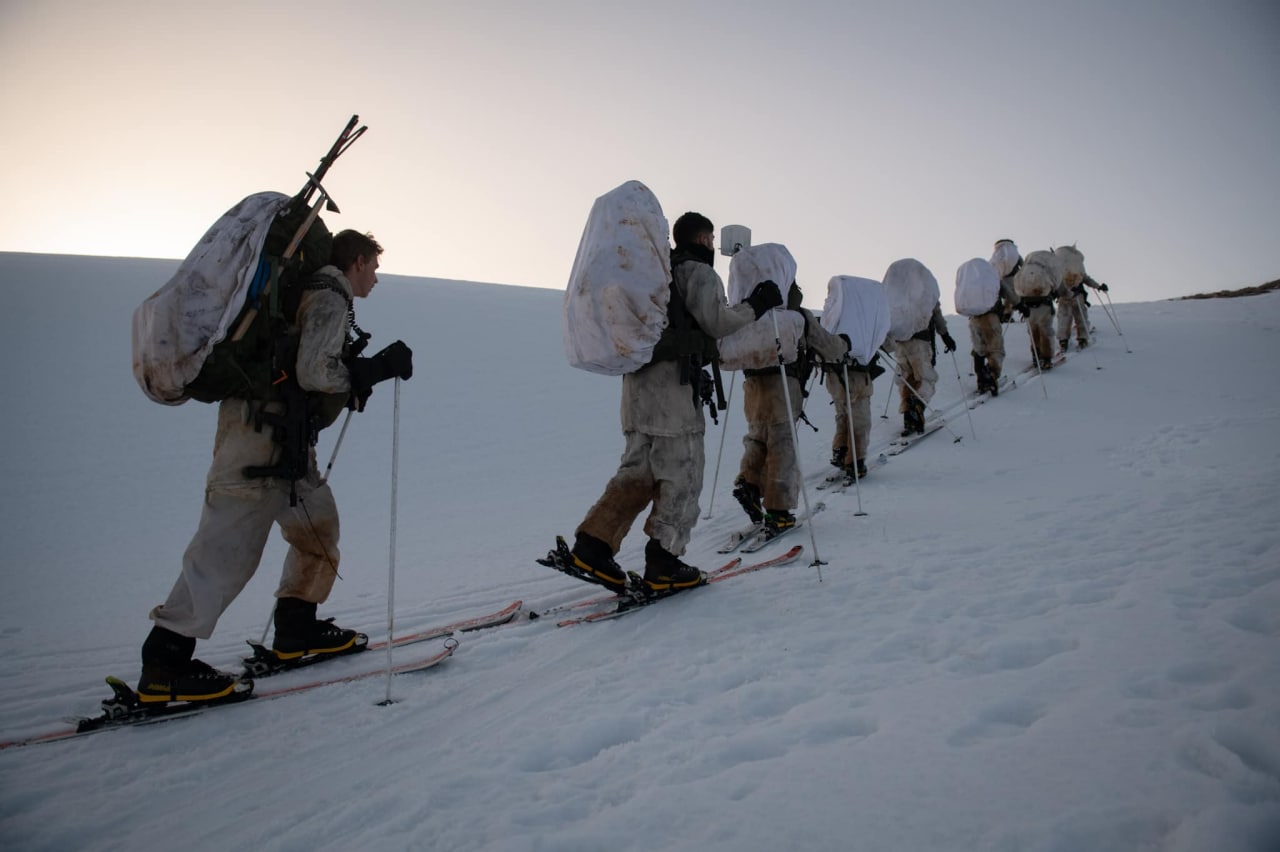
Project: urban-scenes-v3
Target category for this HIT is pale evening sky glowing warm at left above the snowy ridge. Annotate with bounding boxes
[0,0,1280,305]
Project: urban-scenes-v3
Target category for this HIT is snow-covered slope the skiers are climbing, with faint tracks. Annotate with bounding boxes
[0,249,1280,852]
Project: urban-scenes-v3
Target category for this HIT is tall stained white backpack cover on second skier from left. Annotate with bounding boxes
[562,180,671,376]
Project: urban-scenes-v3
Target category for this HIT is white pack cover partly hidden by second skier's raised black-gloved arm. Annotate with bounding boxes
[718,243,804,370]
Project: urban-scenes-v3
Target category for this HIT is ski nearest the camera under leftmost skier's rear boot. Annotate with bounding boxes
[0,638,458,750]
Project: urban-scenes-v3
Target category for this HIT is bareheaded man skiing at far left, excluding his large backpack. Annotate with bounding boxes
[137,230,413,704]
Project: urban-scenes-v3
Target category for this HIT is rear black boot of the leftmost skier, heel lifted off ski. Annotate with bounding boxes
[137,624,245,705]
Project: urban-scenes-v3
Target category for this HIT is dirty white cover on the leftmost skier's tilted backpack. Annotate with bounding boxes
[133,192,289,406]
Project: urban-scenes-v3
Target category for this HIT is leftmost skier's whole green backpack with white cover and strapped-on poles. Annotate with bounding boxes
[133,115,366,406]
